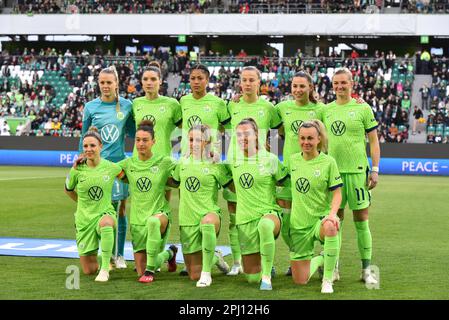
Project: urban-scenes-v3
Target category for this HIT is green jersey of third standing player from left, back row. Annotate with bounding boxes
[180,94,231,153]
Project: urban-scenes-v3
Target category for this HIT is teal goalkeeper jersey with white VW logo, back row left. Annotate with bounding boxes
[79,97,136,162]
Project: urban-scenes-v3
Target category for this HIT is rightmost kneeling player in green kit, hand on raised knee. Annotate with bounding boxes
[289,120,343,293]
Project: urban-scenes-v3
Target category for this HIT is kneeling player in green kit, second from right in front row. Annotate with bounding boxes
[228,118,288,290]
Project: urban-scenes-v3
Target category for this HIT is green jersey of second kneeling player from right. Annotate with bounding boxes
[228,149,288,224]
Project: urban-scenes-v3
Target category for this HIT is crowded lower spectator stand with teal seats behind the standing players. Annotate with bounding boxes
[0,48,414,142]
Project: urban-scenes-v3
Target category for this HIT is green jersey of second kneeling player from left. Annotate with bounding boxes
[118,154,175,226]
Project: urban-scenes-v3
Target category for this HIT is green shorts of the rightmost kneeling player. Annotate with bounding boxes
[289,217,324,261]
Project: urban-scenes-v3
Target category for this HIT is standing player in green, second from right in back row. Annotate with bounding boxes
[276,71,324,275]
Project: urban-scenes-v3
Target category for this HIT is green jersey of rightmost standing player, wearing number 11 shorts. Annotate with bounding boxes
[324,99,377,173]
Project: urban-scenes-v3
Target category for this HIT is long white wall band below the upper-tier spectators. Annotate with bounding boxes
[0,14,449,36]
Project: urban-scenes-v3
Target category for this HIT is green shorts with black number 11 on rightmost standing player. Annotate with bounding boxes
[340,171,371,210]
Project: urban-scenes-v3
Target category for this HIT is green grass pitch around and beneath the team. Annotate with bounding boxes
[0,167,449,300]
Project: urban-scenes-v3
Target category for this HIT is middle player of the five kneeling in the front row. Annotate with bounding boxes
[169,125,232,287]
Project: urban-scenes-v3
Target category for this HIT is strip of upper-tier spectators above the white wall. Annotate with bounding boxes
[7,0,449,14]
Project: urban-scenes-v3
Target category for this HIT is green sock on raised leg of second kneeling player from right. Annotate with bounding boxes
[257,218,275,278]
